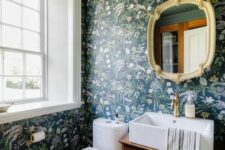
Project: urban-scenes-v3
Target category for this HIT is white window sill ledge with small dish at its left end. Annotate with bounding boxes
[0,101,82,124]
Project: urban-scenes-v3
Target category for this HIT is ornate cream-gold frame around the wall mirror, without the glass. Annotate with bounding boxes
[147,0,216,84]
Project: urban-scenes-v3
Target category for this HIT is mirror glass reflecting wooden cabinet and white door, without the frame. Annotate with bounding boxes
[154,4,208,73]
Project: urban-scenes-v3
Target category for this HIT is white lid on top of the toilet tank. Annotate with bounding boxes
[94,118,128,128]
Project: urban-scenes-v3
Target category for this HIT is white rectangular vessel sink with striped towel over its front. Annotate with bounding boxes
[129,112,214,150]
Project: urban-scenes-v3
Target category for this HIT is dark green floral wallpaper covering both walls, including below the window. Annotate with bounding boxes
[0,0,225,150]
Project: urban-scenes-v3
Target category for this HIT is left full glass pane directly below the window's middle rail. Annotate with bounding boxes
[4,52,23,75]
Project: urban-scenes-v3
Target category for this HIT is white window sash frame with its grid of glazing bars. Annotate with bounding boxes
[0,0,47,104]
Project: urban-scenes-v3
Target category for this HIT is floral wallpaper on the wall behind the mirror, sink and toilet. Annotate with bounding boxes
[82,0,225,150]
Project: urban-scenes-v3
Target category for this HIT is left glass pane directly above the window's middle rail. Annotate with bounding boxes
[2,25,22,48]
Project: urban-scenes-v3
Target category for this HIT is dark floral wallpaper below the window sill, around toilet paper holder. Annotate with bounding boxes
[0,105,93,150]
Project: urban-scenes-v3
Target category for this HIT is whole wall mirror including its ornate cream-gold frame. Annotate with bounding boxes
[148,0,215,83]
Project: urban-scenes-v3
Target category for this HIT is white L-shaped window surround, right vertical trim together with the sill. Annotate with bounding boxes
[0,0,82,124]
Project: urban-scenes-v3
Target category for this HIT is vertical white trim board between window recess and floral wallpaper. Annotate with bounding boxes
[68,0,81,102]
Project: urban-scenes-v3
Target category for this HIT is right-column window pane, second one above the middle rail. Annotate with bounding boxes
[23,8,40,31]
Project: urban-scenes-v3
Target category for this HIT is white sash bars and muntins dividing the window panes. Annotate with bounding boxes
[0,0,47,103]
